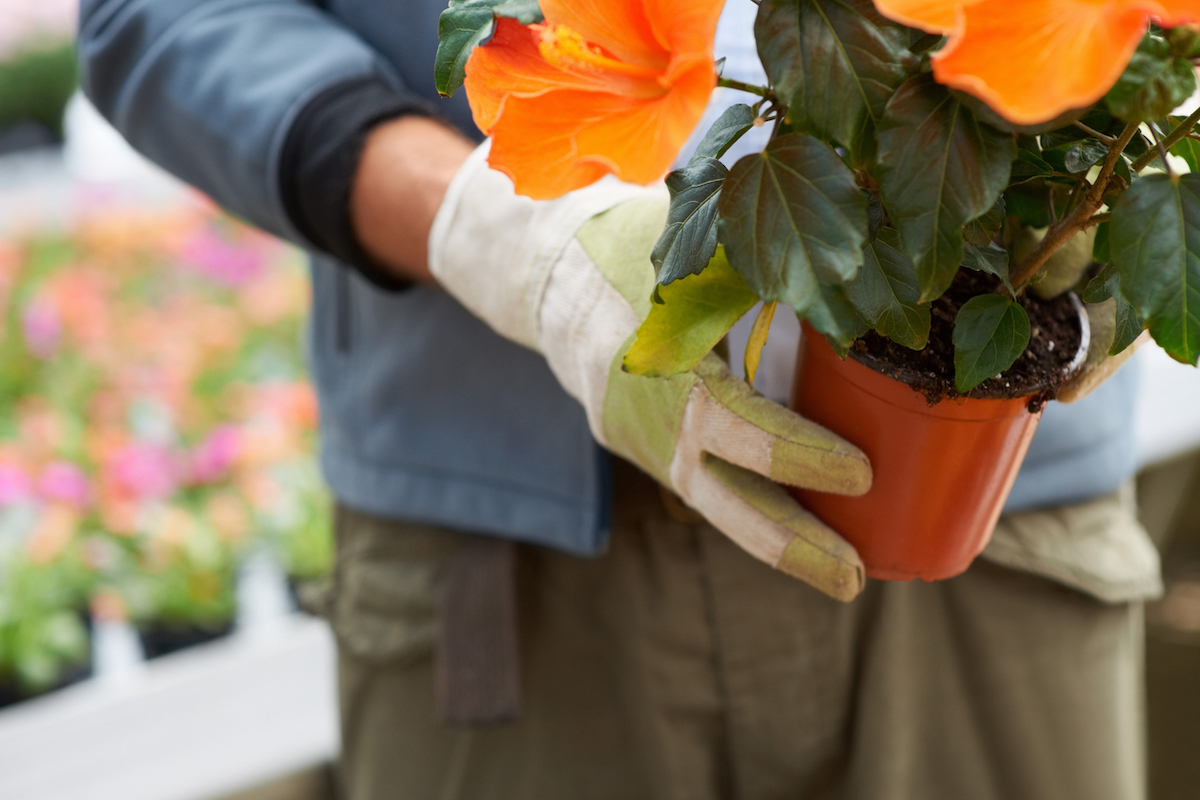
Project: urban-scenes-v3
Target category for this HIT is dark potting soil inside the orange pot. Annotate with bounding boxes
[851,270,1082,411]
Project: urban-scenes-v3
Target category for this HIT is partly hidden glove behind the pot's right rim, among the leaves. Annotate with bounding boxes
[1013,228,1150,403]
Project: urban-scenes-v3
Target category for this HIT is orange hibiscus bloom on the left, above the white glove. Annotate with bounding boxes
[463,0,725,199]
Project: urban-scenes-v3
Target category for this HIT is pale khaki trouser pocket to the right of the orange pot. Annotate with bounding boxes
[983,483,1163,603]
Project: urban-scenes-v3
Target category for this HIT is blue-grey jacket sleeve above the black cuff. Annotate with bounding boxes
[79,0,420,246]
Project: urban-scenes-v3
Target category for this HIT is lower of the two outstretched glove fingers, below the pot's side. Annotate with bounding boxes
[688,456,866,602]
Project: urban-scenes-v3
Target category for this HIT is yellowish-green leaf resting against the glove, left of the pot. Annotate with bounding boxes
[623,251,758,378]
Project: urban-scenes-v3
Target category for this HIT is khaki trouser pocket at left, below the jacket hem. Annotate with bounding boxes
[329,505,462,666]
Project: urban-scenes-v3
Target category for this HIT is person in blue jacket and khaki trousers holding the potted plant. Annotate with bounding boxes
[79,0,1159,800]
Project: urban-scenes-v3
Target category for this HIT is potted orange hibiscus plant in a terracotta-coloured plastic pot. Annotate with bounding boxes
[438,0,1200,579]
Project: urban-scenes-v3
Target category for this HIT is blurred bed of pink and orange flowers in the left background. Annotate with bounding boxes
[0,203,331,693]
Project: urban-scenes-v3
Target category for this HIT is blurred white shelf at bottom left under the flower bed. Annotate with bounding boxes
[0,615,338,800]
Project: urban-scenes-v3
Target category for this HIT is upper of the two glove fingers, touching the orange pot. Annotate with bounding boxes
[680,362,872,497]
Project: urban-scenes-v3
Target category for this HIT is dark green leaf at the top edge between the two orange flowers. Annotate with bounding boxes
[755,0,912,164]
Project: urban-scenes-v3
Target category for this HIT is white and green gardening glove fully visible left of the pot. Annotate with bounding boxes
[430,144,871,601]
